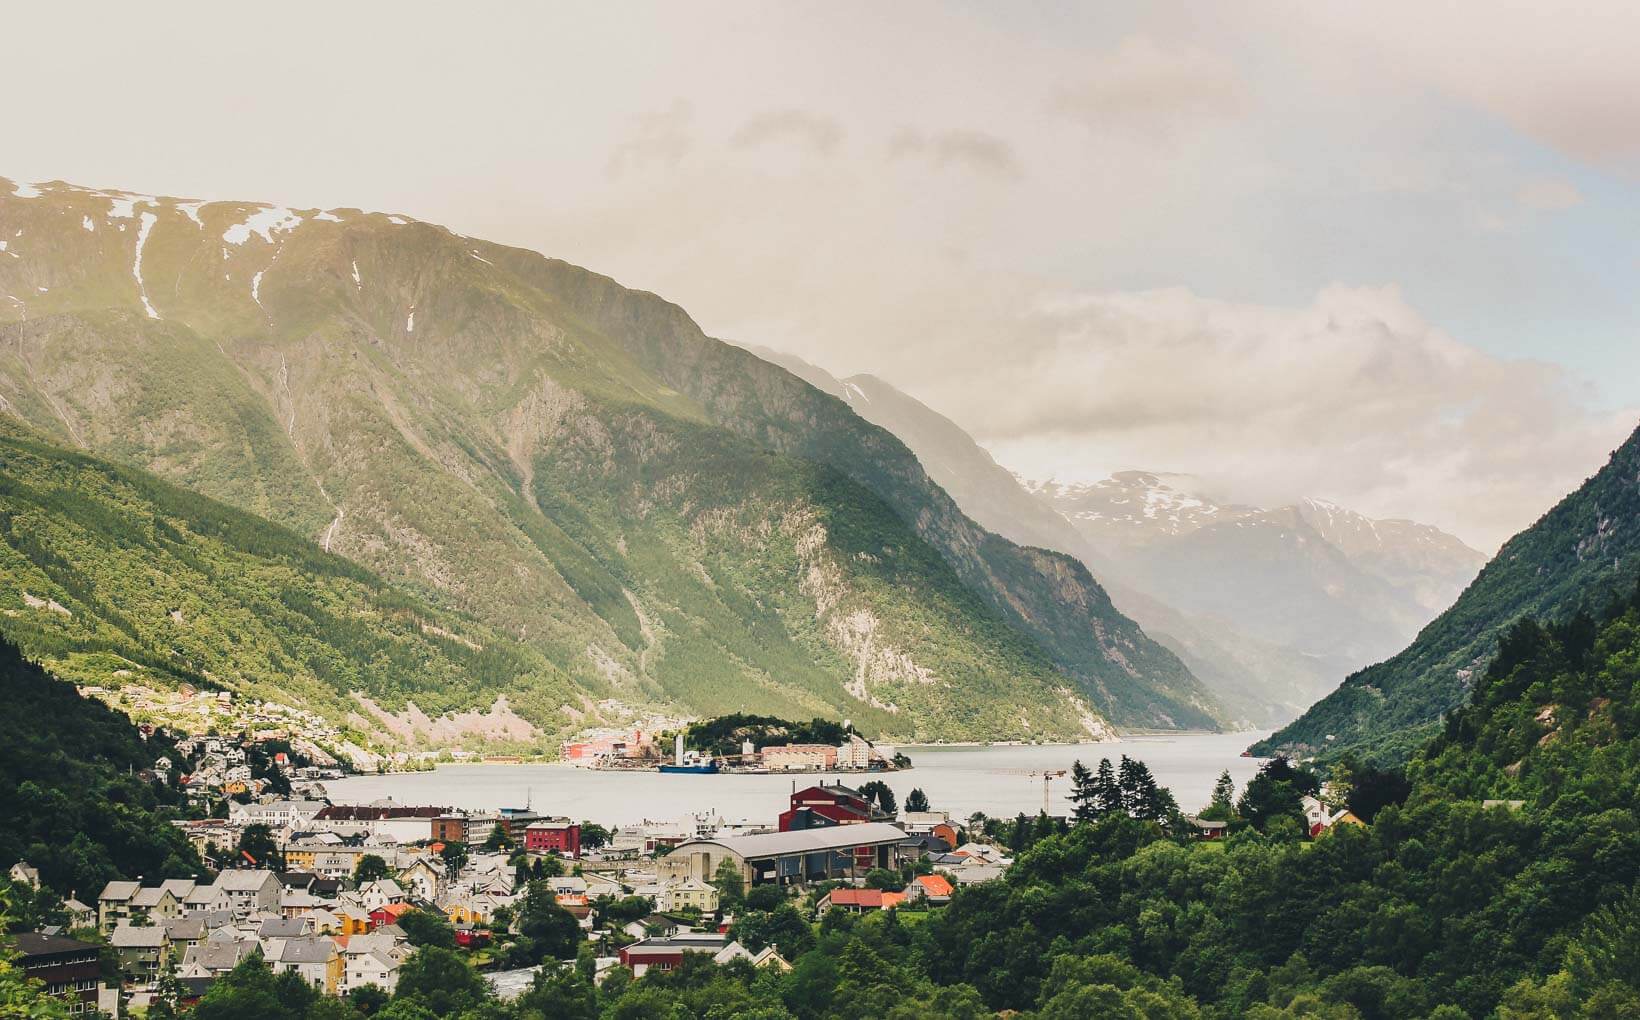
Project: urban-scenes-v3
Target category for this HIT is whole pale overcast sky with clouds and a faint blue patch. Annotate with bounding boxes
[0,0,1640,551]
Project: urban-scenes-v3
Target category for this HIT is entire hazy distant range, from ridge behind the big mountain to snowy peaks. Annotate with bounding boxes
[756,348,1484,725]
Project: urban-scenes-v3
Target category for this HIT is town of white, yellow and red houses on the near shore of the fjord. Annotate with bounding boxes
[10,774,1012,1015]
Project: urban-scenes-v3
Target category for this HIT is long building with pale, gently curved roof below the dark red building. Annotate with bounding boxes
[658,822,907,886]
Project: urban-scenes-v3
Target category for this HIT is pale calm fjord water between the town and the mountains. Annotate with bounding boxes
[325,733,1261,825]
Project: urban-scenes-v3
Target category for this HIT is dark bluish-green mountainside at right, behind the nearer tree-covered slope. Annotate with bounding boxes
[1255,419,1640,758]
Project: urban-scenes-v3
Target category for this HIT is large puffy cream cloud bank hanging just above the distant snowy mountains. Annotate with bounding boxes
[922,287,1640,548]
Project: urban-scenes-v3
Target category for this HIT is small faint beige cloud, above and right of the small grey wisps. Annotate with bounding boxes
[1051,36,1246,138]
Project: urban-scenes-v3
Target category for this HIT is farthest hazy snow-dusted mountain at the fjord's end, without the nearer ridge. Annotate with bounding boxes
[1028,471,1484,708]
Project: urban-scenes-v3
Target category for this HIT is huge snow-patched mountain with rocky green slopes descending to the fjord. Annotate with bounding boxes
[0,184,1219,740]
